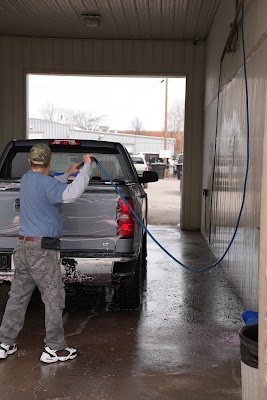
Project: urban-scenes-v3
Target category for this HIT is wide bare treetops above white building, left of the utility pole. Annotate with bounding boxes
[40,102,105,131]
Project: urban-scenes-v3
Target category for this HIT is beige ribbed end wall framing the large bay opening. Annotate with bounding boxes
[0,37,205,229]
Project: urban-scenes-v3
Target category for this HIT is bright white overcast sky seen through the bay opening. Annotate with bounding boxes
[28,75,185,131]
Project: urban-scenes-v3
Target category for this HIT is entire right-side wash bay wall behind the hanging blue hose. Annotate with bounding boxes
[202,0,267,310]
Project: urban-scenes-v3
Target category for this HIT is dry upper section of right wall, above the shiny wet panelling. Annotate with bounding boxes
[205,0,267,106]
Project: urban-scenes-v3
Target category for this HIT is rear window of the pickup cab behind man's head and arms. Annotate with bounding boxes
[1,147,129,181]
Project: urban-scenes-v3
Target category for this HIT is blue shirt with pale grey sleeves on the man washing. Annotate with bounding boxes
[19,164,91,238]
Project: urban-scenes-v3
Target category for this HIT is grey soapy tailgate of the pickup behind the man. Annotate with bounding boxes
[0,186,129,252]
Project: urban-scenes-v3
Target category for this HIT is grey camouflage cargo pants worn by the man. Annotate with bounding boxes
[0,240,67,350]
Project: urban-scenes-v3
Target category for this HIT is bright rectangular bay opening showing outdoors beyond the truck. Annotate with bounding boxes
[27,74,186,227]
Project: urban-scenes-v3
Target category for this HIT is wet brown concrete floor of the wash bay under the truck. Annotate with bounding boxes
[0,225,243,400]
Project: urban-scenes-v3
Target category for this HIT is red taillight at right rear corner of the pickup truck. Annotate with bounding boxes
[118,199,135,238]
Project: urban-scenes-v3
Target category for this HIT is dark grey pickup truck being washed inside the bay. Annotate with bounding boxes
[0,139,158,309]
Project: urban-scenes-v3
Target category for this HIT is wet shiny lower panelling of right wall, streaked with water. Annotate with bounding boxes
[211,61,267,309]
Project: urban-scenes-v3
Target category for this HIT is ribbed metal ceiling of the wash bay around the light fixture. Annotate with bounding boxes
[0,0,221,40]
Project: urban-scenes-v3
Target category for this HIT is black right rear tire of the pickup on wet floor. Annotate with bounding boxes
[114,250,146,310]
